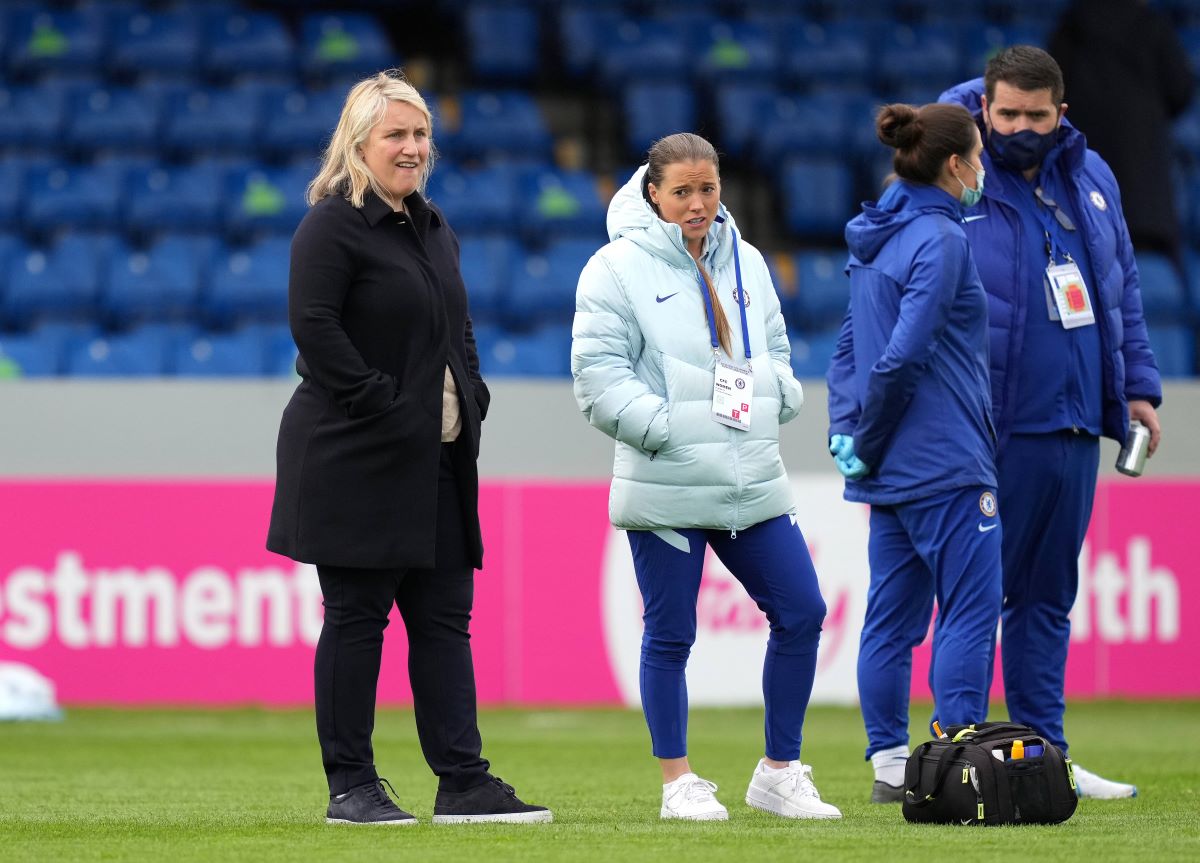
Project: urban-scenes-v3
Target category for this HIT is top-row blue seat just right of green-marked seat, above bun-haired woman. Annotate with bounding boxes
[782,18,874,86]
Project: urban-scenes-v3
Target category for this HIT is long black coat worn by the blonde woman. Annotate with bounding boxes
[266,192,490,568]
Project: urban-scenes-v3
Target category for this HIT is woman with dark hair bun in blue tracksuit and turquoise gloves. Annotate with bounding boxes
[828,104,1001,803]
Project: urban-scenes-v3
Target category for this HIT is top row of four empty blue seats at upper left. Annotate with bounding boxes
[0,0,391,79]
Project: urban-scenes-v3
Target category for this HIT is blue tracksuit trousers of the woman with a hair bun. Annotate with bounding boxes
[858,487,1009,759]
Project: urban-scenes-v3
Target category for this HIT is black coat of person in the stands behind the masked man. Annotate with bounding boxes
[1049,0,1193,253]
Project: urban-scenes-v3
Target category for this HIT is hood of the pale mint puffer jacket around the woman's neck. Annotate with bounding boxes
[607,164,737,270]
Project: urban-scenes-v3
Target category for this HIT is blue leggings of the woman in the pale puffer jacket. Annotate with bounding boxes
[629,515,826,761]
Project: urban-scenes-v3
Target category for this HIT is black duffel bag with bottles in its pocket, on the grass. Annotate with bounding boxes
[902,723,1078,825]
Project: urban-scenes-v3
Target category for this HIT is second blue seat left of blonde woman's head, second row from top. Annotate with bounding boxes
[162,88,262,157]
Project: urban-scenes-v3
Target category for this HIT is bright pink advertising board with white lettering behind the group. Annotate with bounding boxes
[0,477,1200,705]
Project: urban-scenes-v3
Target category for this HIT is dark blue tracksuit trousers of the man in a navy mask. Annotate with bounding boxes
[996,431,1100,754]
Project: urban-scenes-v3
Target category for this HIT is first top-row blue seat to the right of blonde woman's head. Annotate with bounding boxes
[466,2,541,80]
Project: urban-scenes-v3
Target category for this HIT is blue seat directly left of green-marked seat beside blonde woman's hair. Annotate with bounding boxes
[125,161,224,234]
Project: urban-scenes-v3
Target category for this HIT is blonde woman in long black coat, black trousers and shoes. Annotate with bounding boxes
[266,72,552,825]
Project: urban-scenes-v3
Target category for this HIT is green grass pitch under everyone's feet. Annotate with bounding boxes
[0,701,1200,863]
